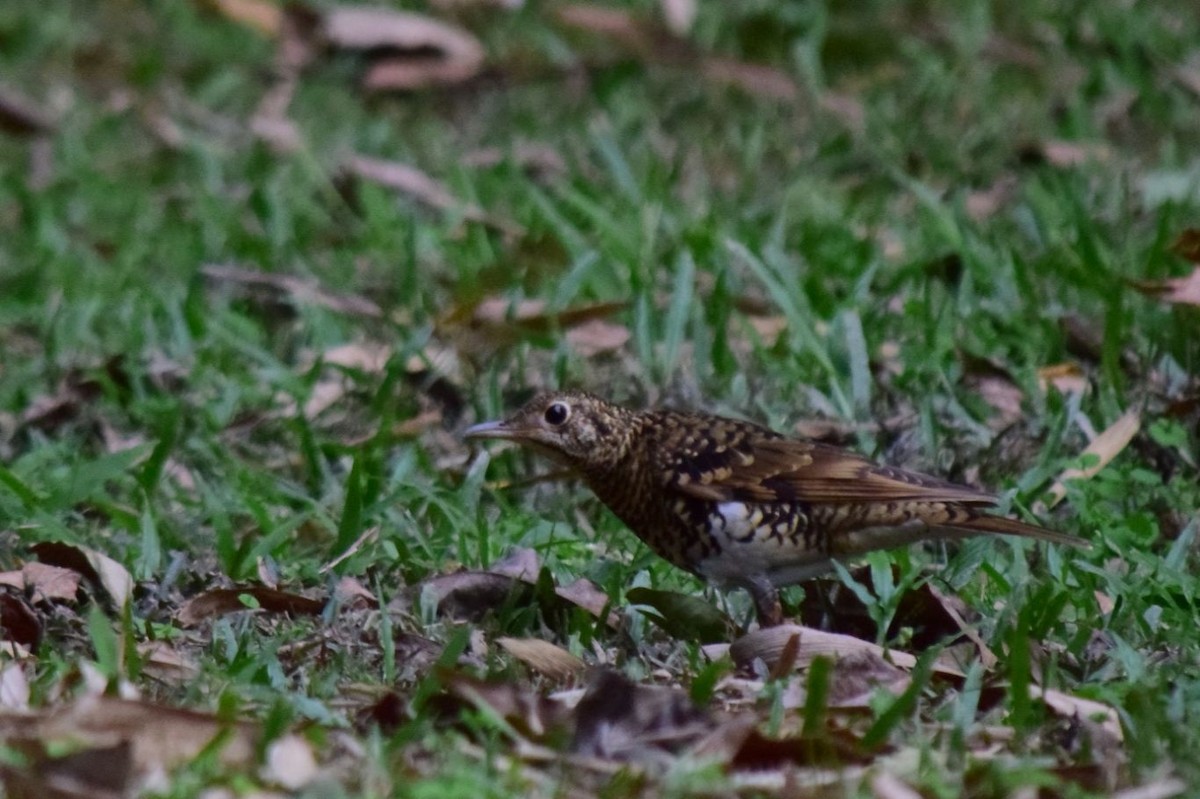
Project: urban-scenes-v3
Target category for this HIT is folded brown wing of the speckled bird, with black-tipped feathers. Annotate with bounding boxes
[654,417,995,505]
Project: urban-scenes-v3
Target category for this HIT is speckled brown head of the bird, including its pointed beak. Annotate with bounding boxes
[464,391,636,471]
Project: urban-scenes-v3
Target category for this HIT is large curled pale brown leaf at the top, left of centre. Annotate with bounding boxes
[324,6,485,91]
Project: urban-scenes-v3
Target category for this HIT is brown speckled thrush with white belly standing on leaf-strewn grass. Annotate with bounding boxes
[463,391,1087,627]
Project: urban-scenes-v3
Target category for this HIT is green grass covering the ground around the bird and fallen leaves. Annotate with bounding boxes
[0,0,1200,797]
